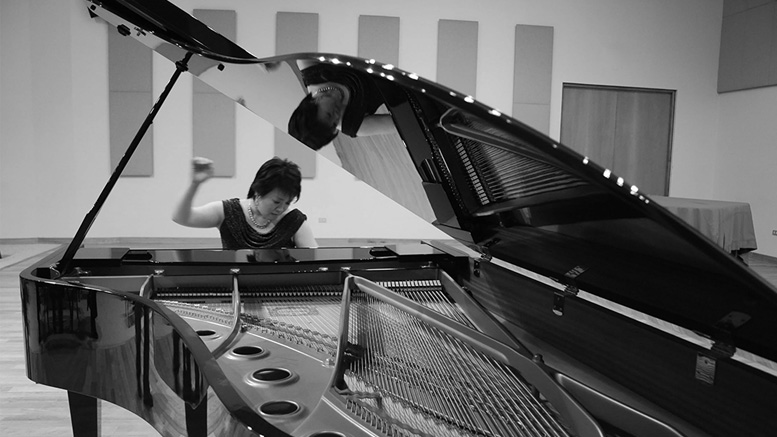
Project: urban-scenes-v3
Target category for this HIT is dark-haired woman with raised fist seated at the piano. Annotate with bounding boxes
[173,157,316,249]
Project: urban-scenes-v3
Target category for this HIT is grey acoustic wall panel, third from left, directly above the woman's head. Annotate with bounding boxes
[275,12,318,178]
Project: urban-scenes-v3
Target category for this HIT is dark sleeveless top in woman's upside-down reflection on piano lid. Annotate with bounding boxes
[302,64,384,137]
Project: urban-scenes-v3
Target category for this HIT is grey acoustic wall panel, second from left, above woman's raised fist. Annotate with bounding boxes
[192,9,237,177]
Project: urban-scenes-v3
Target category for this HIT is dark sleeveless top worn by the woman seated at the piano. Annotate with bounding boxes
[219,199,307,250]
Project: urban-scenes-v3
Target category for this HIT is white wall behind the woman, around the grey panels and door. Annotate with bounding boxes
[0,0,777,255]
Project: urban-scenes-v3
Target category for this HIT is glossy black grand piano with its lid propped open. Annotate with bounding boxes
[16,0,777,437]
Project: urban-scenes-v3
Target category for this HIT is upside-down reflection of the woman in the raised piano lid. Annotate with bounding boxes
[288,61,395,150]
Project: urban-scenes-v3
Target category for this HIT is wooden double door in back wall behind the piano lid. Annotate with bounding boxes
[561,84,674,195]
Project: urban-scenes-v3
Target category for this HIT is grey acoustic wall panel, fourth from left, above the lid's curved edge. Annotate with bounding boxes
[356,15,399,65]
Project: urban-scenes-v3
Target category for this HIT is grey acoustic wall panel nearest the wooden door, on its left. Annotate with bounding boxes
[512,24,553,134]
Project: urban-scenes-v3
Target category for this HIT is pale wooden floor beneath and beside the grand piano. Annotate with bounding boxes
[0,244,777,437]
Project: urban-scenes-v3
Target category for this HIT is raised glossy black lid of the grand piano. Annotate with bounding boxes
[79,0,777,361]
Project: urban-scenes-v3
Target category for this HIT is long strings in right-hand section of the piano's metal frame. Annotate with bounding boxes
[336,278,569,436]
